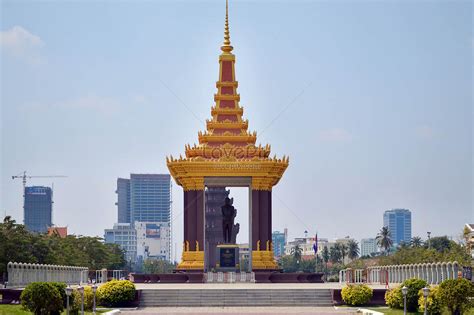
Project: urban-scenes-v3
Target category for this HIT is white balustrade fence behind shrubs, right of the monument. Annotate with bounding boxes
[367,261,461,284]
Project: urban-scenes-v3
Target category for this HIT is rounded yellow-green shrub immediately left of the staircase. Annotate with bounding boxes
[97,280,135,306]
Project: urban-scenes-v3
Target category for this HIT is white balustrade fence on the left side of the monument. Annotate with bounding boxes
[7,262,89,288]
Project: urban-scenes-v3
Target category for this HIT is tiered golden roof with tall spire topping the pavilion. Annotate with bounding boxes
[166,3,289,190]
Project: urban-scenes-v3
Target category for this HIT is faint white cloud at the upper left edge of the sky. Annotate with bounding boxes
[0,25,45,63]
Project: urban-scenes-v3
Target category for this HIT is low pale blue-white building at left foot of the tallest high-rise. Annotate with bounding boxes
[104,223,137,264]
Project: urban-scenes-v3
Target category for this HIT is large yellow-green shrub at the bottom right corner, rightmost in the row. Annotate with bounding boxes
[439,279,474,314]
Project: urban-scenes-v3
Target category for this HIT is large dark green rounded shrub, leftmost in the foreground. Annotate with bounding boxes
[20,282,64,315]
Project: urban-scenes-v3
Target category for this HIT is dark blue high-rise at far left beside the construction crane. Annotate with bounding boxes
[24,186,53,233]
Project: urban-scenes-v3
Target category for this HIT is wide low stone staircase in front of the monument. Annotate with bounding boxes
[140,288,333,307]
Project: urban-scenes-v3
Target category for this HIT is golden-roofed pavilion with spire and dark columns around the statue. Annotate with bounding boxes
[166,3,289,271]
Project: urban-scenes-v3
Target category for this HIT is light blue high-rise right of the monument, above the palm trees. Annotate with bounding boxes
[383,209,411,245]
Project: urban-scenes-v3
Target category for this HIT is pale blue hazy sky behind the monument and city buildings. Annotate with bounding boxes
[0,1,474,258]
